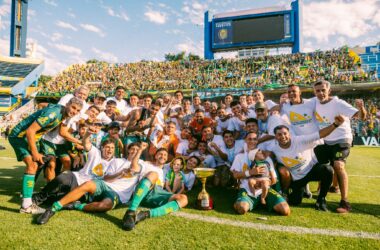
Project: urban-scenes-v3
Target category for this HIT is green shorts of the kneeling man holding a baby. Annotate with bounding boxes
[235,188,286,211]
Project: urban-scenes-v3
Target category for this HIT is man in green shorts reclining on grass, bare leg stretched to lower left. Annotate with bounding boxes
[37,143,148,225]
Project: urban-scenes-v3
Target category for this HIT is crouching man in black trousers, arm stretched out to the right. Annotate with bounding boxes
[267,115,344,211]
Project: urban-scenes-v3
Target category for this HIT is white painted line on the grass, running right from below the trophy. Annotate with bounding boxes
[172,212,380,240]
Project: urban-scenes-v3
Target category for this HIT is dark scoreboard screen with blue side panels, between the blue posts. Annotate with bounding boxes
[212,13,292,49]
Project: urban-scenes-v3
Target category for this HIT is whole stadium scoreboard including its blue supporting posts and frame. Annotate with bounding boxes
[205,0,301,59]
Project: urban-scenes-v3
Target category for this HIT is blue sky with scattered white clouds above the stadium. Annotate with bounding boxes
[0,0,380,74]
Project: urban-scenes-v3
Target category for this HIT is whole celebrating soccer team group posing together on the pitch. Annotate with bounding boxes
[8,80,367,230]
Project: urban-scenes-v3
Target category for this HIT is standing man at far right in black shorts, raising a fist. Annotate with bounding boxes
[314,80,367,213]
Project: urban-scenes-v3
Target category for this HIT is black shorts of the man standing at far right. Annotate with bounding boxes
[314,143,351,164]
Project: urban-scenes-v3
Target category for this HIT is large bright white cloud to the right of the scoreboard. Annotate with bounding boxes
[303,0,380,42]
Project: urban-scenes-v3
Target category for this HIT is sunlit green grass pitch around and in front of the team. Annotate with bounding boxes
[0,139,380,249]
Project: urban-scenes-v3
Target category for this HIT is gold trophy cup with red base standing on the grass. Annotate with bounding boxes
[194,168,215,210]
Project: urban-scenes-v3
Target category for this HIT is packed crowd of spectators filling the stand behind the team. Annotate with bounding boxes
[41,49,378,93]
